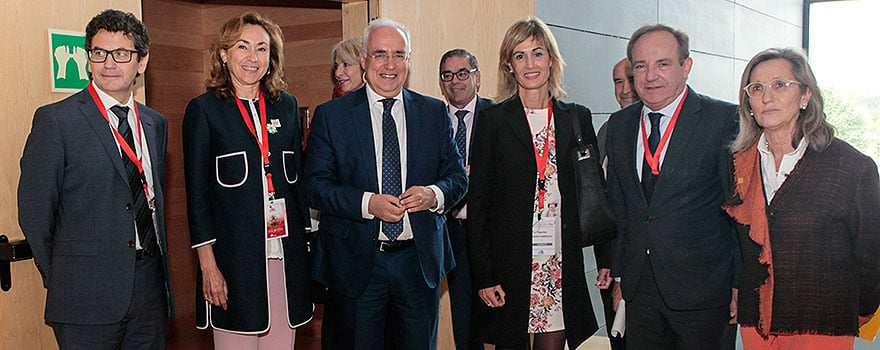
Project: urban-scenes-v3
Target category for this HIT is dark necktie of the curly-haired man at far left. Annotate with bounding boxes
[110,106,156,255]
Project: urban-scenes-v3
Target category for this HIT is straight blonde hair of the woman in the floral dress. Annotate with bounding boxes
[498,17,568,101]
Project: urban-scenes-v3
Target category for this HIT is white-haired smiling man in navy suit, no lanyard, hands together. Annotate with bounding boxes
[304,19,467,349]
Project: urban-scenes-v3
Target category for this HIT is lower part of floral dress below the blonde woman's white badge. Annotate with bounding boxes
[529,252,565,333]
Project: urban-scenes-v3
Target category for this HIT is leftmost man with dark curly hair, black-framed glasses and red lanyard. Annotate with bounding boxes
[18,10,174,349]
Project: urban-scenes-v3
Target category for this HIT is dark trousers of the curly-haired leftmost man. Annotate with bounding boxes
[52,252,168,350]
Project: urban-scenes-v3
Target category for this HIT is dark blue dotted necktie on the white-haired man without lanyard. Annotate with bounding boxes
[382,98,403,241]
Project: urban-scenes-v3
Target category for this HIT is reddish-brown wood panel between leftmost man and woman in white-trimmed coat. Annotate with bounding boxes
[144,0,213,349]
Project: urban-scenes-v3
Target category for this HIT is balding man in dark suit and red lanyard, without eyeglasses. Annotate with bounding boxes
[606,24,739,349]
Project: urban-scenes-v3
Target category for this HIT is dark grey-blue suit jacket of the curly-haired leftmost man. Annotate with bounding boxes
[18,90,174,324]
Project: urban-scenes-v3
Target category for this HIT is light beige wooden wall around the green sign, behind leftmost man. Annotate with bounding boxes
[0,0,144,349]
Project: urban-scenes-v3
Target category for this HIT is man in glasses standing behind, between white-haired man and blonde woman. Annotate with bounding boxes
[440,49,495,349]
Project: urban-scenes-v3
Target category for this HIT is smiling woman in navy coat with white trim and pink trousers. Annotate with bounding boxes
[183,13,313,349]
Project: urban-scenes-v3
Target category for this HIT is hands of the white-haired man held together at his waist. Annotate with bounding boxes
[369,186,437,222]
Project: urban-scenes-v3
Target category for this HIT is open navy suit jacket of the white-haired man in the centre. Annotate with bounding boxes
[304,88,467,298]
